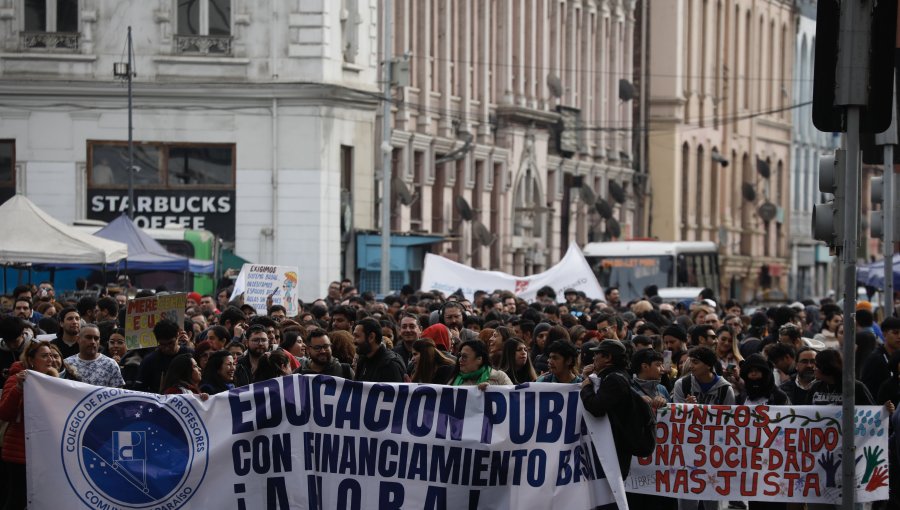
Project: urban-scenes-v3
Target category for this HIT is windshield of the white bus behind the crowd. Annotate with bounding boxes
[585,255,673,303]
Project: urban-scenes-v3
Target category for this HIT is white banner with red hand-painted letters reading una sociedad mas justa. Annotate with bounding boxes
[625,404,889,505]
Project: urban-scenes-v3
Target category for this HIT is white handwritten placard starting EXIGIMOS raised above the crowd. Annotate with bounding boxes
[229,264,300,317]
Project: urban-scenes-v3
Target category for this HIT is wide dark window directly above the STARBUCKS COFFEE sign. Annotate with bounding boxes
[88,141,235,189]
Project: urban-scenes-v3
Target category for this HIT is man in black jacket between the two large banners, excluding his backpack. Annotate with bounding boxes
[581,340,633,480]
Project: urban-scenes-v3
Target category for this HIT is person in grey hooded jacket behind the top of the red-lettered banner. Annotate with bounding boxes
[672,346,734,510]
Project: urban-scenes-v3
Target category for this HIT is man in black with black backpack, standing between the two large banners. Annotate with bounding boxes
[581,340,656,508]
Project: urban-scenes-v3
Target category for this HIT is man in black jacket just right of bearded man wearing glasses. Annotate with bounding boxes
[353,318,406,382]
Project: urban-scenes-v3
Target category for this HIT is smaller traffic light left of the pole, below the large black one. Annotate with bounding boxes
[812,149,847,248]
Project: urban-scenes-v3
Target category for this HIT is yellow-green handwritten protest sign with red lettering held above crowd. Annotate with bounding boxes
[125,293,187,350]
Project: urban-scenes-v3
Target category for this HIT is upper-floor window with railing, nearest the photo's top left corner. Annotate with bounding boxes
[21,0,79,51]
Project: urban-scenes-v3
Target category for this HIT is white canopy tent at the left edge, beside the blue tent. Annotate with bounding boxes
[0,195,128,264]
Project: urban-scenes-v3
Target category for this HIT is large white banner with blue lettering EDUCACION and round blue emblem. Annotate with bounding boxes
[25,372,624,510]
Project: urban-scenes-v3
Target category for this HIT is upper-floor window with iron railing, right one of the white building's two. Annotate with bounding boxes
[175,0,232,56]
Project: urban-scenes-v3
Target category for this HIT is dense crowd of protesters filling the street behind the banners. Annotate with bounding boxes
[0,280,900,510]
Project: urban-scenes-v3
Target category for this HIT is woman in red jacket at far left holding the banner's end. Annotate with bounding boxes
[0,342,57,510]
